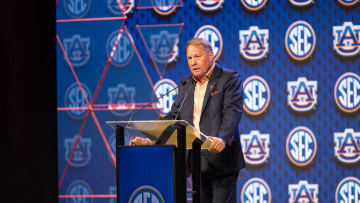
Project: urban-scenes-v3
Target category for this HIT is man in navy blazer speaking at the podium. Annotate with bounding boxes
[130,38,245,203]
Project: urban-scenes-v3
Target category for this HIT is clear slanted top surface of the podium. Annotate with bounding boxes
[106,120,212,149]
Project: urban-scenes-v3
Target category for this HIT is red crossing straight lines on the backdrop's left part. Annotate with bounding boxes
[56,1,184,199]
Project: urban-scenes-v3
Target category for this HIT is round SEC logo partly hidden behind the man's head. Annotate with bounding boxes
[194,25,223,60]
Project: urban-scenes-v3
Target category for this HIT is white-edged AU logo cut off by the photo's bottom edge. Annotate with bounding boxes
[288,180,319,203]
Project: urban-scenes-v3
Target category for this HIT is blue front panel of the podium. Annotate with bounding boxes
[118,146,175,203]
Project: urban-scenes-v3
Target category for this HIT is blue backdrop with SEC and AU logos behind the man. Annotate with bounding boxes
[56,0,360,202]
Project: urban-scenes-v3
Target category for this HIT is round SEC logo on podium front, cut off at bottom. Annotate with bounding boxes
[129,185,165,203]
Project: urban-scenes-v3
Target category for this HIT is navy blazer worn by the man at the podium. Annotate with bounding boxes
[164,64,245,175]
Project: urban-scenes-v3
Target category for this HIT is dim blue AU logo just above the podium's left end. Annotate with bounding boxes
[108,83,135,116]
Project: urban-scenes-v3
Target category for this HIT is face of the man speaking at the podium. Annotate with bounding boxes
[186,45,214,79]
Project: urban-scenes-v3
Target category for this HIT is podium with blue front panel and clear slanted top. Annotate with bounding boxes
[106,120,211,203]
